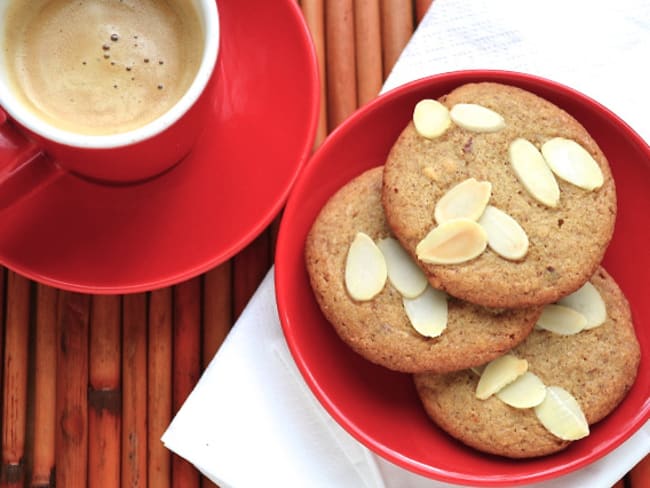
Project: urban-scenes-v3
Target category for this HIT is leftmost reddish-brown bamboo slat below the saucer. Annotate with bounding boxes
[0,271,30,487]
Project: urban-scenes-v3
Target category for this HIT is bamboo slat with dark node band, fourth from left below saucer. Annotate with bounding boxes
[88,295,122,488]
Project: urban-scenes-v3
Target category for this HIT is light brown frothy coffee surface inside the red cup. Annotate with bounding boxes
[5,0,204,135]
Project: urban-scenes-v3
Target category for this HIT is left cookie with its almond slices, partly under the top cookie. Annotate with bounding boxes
[305,167,541,372]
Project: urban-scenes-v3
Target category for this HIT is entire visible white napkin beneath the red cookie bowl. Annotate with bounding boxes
[162,0,650,488]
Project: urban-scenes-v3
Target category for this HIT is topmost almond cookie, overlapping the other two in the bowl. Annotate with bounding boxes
[382,83,616,308]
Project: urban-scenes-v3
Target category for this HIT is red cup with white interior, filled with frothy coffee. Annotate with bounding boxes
[0,0,220,187]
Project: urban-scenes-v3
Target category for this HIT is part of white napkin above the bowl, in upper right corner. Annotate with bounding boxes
[384,0,650,145]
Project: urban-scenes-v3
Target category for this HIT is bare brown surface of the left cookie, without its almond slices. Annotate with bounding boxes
[305,167,540,372]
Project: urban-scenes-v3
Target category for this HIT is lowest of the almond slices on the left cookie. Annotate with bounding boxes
[402,286,447,337]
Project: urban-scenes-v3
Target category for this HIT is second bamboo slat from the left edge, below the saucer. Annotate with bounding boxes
[31,285,59,488]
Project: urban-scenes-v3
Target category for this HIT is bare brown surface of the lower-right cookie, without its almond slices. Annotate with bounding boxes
[414,268,640,458]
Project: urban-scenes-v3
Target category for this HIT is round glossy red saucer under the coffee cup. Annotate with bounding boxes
[0,0,319,293]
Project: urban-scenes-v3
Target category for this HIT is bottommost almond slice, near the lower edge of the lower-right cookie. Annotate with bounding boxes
[535,386,589,441]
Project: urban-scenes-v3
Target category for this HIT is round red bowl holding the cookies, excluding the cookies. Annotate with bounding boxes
[275,70,650,486]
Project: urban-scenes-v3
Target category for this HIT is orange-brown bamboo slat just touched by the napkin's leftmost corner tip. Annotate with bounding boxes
[147,288,173,488]
